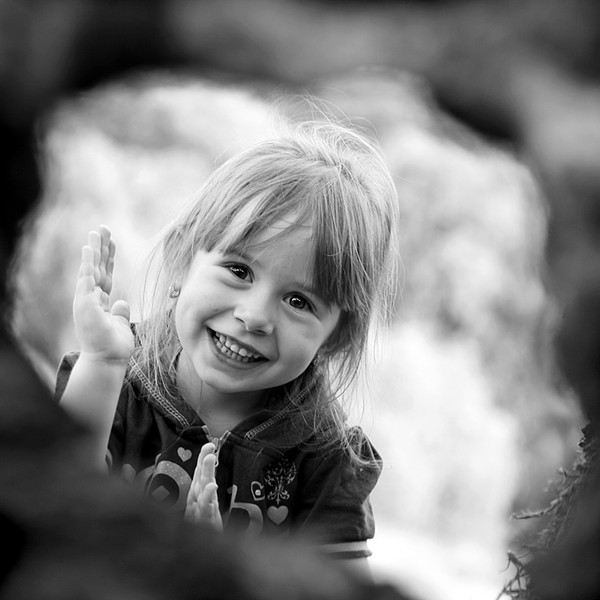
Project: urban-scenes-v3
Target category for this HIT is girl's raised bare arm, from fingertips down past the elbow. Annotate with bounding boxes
[61,226,134,466]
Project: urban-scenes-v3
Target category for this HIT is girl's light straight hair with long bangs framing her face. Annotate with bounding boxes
[136,120,399,460]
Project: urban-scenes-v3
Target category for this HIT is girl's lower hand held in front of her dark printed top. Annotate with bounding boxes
[185,442,223,531]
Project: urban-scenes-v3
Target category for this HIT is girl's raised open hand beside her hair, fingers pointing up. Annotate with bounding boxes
[73,225,134,362]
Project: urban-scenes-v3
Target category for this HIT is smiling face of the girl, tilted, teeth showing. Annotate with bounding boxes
[175,222,340,404]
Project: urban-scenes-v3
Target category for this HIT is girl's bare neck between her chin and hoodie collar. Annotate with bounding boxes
[177,362,266,437]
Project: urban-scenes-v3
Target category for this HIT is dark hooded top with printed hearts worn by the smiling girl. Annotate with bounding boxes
[56,353,381,558]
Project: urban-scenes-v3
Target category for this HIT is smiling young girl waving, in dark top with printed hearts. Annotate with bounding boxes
[57,116,398,558]
